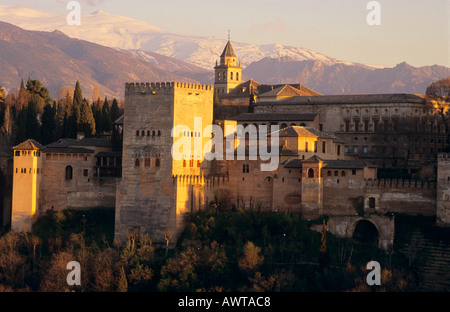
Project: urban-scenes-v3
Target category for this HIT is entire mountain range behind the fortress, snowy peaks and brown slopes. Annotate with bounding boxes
[0,6,450,98]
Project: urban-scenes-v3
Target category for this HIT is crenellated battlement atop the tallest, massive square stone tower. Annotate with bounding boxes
[125,82,213,95]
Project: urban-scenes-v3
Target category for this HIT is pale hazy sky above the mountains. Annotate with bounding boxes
[0,0,450,67]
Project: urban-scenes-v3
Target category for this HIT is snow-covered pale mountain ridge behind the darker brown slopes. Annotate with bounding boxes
[0,6,382,71]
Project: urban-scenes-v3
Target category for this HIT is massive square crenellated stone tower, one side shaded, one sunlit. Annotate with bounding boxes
[115,82,214,244]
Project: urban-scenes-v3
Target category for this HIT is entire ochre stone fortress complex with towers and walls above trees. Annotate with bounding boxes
[7,42,450,249]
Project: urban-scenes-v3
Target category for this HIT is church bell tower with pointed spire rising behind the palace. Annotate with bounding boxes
[214,38,242,96]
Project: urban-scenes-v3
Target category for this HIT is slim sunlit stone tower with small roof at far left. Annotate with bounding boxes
[11,140,44,232]
